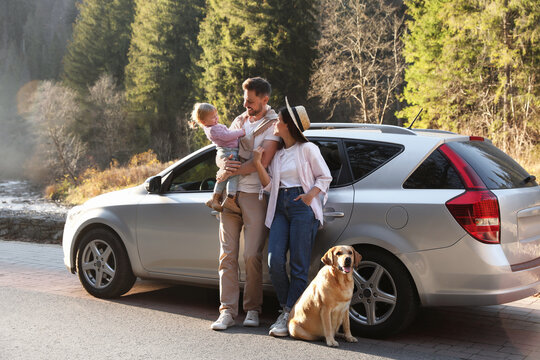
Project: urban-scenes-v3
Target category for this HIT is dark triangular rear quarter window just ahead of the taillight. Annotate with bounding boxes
[403,150,464,189]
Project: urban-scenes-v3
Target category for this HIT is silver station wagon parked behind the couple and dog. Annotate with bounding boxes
[63,124,540,337]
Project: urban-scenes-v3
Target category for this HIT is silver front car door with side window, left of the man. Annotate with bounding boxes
[137,148,219,279]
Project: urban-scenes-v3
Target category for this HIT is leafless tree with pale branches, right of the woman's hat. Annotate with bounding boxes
[309,0,405,123]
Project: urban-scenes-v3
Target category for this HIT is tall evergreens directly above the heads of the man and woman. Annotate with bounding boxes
[199,0,317,122]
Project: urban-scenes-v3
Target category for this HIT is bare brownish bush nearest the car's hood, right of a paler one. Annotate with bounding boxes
[88,74,129,166]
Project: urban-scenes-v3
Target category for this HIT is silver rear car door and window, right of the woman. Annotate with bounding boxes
[310,138,354,278]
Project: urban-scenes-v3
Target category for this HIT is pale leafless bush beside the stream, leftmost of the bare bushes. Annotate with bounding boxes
[31,81,85,182]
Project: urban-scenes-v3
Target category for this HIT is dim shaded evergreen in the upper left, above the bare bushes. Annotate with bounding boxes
[63,0,134,93]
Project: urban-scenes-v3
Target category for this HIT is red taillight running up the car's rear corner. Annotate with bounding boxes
[439,144,501,244]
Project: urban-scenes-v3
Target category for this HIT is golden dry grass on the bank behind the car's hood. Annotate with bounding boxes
[45,150,172,205]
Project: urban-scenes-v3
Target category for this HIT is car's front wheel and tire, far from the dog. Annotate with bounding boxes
[77,229,136,299]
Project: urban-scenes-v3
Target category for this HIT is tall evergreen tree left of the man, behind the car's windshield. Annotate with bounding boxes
[126,0,204,160]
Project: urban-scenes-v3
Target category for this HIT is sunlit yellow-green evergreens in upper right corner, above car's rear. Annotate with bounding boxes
[399,0,540,145]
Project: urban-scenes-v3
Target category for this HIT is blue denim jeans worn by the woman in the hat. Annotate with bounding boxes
[268,187,319,310]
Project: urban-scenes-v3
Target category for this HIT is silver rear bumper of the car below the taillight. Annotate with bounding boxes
[403,236,540,306]
